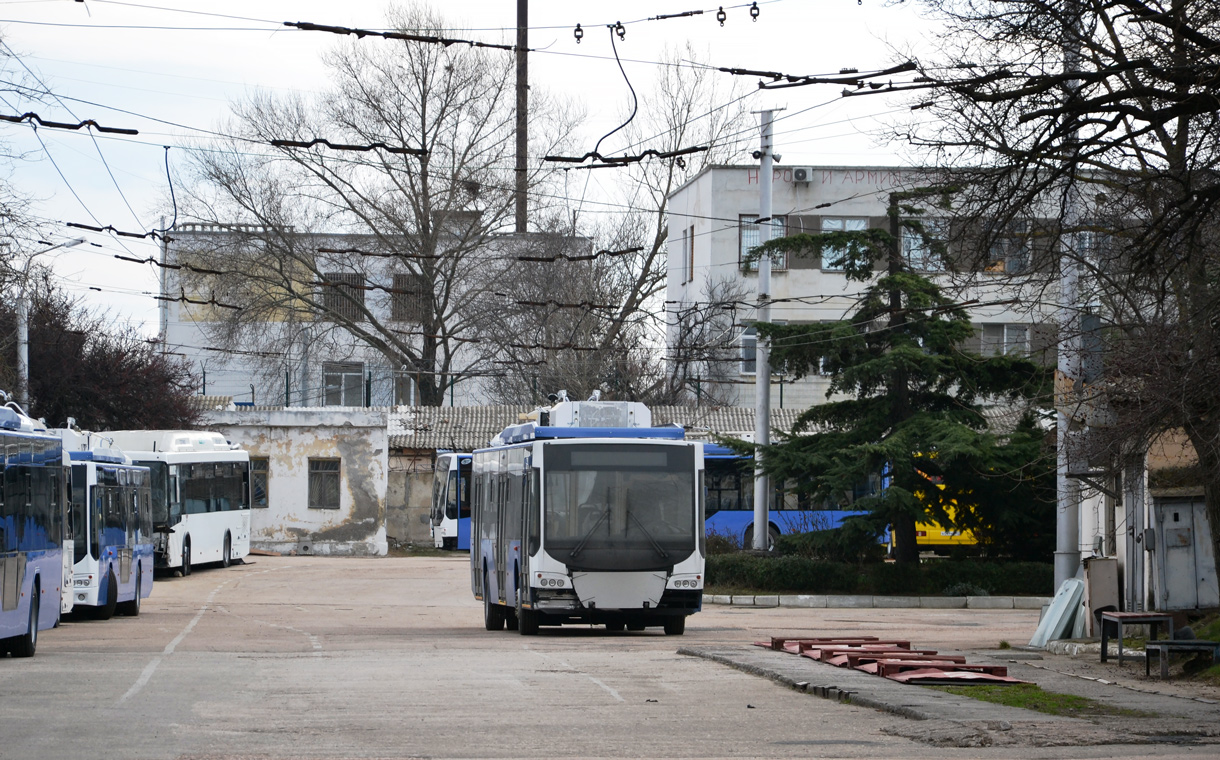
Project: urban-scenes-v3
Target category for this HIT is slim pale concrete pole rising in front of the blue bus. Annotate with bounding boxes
[754,111,772,550]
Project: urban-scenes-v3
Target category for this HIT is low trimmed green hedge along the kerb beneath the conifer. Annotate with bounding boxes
[706,554,1055,597]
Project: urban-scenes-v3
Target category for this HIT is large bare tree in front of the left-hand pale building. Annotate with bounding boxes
[178,6,576,404]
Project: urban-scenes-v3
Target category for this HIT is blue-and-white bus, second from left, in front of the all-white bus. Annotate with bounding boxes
[52,428,155,620]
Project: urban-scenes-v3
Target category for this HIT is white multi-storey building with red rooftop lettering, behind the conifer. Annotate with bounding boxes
[666,166,1053,409]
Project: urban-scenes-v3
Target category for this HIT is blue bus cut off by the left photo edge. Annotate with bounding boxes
[0,404,65,658]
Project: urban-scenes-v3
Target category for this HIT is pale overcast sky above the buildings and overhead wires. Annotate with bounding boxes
[0,0,932,334]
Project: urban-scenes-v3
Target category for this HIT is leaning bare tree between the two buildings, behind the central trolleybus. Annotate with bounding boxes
[485,45,749,404]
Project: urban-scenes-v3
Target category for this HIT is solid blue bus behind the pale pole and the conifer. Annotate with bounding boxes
[703,443,867,549]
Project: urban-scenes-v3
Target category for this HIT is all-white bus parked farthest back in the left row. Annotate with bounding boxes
[104,431,250,576]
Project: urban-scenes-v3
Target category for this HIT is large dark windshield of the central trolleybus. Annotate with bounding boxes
[543,443,702,571]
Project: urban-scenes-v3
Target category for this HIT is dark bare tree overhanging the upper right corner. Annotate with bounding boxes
[898,0,1220,570]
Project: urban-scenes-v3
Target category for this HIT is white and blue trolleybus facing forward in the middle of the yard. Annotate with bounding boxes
[470,401,705,636]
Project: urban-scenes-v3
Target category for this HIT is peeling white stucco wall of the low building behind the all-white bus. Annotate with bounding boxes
[206,409,389,555]
